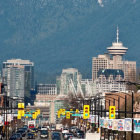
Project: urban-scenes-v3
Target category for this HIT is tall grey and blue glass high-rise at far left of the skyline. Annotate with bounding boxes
[2,59,34,97]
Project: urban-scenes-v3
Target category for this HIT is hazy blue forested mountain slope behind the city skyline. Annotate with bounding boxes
[0,0,140,82]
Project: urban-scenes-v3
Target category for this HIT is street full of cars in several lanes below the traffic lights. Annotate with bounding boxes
[9,125,85,140]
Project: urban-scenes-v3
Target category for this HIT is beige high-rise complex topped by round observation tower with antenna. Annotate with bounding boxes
[92,28,136,81]
